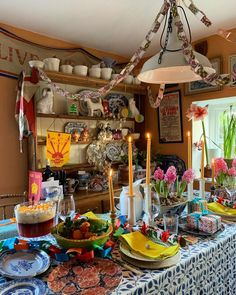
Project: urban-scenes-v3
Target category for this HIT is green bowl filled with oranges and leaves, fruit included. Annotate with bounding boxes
[52,216,112,249]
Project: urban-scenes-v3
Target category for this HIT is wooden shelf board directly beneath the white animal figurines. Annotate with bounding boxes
[36,113,134,121]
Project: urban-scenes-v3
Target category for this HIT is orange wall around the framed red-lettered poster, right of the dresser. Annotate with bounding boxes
[145,35,236,166]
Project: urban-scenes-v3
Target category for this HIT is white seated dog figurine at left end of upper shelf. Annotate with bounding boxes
[36,88,55,114]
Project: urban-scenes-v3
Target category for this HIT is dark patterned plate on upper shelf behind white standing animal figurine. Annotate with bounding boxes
[105,93,128,115]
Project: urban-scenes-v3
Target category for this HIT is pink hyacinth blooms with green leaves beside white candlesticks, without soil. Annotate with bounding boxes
[153,166,194,205]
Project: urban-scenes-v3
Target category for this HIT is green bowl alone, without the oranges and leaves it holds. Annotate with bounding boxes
[52,219,112,249]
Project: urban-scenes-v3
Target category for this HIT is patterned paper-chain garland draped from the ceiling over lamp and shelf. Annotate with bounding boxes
[38,0,232,108]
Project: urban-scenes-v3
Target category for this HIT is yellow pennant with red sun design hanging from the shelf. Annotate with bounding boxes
[46,131,71,167]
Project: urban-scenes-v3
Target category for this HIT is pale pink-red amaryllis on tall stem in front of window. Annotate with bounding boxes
[186,104,212,177]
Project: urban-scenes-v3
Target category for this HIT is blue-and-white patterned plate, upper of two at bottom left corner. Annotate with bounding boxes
[0,249,50,279]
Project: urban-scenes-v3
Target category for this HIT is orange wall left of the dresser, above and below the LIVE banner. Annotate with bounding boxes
[0,24,127,194]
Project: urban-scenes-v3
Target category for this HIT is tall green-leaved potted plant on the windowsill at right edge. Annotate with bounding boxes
[221,105,236,166]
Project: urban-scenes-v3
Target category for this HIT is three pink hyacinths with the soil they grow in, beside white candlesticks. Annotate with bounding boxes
[152,166,194,207]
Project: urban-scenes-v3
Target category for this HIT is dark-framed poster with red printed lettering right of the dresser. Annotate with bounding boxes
[157,90,183,143]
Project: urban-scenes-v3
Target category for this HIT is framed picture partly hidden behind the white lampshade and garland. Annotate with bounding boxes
[184,56,222,95]
